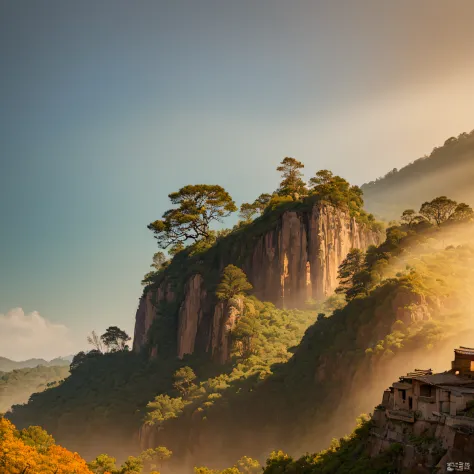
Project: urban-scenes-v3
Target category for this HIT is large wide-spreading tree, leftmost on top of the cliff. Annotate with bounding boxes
[148,184,237,249]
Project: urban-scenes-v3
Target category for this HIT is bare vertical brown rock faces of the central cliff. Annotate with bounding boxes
[134,203,381,361]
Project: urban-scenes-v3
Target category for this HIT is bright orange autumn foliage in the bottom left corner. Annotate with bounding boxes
[0,416,92,474]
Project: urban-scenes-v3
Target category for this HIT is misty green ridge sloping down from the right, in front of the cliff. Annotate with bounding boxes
[132,199,474,466]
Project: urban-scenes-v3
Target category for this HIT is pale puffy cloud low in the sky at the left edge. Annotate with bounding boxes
[0,308,75,360]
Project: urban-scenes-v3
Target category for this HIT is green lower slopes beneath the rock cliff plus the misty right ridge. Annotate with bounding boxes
[8,217,474,472]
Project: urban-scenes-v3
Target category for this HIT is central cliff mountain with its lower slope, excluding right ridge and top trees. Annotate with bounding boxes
[9,181,382,457]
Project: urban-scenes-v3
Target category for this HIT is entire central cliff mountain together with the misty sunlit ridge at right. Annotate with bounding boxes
[8,162,474,473]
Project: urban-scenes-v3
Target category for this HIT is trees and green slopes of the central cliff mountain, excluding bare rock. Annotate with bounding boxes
[8,158,380,459]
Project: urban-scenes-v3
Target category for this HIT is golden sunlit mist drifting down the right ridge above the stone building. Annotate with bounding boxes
[284,224,474,462]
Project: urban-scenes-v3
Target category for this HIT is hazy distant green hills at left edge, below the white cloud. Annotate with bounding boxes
[0,365,69,413]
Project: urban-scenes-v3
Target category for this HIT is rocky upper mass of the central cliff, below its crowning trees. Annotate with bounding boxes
[134,202,381,362]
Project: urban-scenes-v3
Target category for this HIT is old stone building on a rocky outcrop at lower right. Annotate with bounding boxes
[370,347,474,473]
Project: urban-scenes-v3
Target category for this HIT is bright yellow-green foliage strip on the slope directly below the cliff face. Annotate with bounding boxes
[145,297,315,446]
